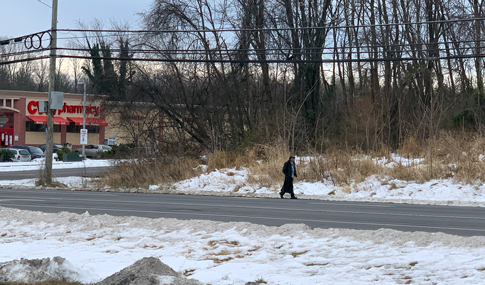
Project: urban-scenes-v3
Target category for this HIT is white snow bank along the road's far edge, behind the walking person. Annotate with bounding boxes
[167,165,485,206]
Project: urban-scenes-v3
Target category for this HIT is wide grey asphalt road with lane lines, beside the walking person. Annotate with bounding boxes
[0,189,485,236]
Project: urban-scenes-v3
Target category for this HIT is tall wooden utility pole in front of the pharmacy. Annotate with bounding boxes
[44,0,58,185]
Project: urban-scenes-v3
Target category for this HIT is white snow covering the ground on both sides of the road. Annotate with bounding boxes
[0,156,485,285]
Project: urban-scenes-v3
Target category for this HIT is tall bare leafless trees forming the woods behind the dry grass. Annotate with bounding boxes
[0,0,485,151]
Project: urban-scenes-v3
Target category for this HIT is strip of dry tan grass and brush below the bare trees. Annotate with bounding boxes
[100,132,485,188]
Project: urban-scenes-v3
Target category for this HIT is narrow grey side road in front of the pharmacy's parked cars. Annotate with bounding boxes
[0,166,110,180]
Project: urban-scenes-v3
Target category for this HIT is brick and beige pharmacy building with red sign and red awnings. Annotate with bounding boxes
[0,90,108,147]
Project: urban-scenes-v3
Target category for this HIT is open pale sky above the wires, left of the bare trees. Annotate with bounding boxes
[0,0,153,38]
